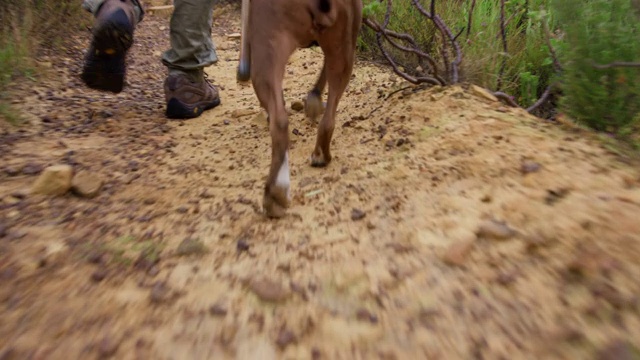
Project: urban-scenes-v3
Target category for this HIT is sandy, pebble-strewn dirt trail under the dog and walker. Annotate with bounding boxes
[0,6,640,359]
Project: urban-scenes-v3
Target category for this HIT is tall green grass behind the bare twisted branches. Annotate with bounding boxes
[359,0,556,106]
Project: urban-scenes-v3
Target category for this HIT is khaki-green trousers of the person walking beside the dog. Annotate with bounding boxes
[82,0,218,81]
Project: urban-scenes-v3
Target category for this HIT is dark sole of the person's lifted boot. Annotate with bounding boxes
[81,10,133,93]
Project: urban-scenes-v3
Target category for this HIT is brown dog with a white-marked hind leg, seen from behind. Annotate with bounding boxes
[237,0,362,218]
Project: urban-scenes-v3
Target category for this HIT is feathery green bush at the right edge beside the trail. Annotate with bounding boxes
[553,0,640,136]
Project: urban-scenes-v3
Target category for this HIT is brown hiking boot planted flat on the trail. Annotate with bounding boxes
[164,74,220,119]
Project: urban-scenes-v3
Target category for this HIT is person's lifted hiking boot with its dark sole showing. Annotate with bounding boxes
[81,0,142,93]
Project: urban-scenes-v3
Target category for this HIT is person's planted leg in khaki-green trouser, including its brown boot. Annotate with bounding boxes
[162,0,220,119]
